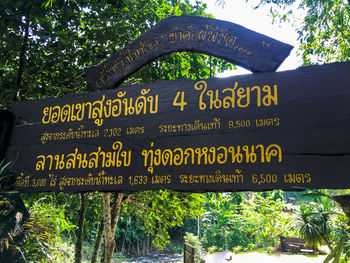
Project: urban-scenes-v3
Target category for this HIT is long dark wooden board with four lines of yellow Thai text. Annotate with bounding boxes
[7,63,350,192]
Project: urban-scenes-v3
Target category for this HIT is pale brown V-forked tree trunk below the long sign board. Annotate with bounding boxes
[103,193,124,263]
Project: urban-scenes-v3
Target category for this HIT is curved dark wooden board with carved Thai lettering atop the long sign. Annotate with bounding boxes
[86,16,293,90]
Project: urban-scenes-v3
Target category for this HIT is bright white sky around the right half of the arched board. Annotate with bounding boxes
[194,0,301,77]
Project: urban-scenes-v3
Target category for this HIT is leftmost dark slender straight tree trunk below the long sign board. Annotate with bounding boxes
[74,193,86,263]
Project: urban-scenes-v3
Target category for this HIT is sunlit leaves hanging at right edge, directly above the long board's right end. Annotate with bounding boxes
[299,0,350,64]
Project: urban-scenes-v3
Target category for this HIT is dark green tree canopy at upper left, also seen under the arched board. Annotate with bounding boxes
[0,0,232,108]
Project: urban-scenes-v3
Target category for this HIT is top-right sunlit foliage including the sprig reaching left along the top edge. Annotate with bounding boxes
[247,0,350,65]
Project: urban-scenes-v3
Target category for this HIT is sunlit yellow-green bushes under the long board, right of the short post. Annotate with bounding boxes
[202,191,295,251]
